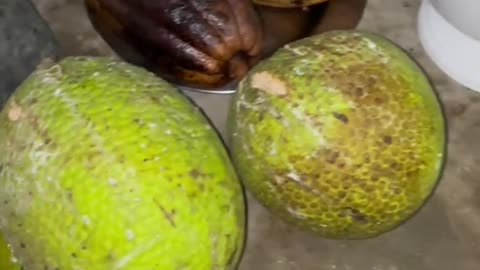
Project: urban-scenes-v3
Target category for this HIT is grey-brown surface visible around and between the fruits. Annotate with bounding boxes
[30,0,480,270]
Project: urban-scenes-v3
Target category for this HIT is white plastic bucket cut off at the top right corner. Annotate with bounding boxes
[417,0,480,92]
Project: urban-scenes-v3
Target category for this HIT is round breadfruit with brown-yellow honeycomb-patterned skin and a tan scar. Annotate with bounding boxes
[228,30,446,239]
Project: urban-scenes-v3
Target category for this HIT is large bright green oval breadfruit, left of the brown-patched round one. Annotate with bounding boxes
[0,57,245,270]
